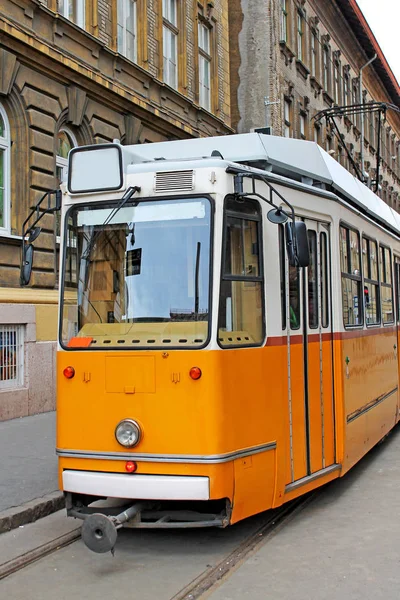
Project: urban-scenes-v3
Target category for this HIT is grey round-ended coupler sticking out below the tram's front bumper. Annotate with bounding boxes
[81,503,142,556]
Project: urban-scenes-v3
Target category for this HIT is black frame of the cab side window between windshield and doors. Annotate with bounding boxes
[217,194,267,350]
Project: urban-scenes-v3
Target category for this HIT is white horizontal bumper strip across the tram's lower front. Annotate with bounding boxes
[62,470,210,500]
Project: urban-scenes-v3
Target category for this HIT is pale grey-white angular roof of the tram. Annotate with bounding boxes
[125,133,400,233]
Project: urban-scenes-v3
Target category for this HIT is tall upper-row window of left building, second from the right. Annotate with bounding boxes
[162,0,178,89]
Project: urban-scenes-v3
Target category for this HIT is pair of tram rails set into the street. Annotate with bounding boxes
[0,490,319,600]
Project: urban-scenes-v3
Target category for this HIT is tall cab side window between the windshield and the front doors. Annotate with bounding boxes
[218,198,264,348]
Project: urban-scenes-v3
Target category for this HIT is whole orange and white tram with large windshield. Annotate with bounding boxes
[23,133,400,552]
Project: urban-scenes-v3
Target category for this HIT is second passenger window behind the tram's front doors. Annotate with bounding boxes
[362,237,381,325]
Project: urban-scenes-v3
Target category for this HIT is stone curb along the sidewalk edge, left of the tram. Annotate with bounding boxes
[0,492,65,534]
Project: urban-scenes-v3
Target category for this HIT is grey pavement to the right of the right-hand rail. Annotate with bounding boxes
[207,427,400,600]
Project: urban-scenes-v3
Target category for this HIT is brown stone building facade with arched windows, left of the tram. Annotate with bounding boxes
[0,0,232,420]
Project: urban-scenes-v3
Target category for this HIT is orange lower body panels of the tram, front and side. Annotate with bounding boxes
[57,329,398,523]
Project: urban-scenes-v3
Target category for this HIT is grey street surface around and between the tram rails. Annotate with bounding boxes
[0,428,400,600]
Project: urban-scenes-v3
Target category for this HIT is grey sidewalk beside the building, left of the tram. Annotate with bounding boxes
[0,412,62,532]
